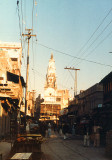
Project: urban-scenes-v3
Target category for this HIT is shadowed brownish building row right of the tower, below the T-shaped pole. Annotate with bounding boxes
[62,83,103,130]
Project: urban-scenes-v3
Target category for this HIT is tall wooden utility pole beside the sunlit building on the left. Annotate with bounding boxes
[22,29,36,128]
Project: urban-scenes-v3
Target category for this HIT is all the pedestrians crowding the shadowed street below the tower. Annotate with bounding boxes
[24,121,101,147]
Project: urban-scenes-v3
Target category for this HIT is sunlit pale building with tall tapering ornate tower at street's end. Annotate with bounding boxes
[40,54,69,120]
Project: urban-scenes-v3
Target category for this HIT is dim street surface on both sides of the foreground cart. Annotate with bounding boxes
[0,132,110,160]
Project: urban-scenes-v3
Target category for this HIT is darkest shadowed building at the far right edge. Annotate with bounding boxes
[98,72,112,132]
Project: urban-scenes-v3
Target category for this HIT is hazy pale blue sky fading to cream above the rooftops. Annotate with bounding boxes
[0,0,112,95]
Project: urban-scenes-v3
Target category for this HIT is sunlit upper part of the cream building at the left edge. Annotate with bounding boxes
[0,43,24,99]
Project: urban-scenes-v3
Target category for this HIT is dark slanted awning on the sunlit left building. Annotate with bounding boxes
[7,71,25,87]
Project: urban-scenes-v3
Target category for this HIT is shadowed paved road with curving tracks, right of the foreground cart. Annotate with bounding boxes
[42,132,108,160]
